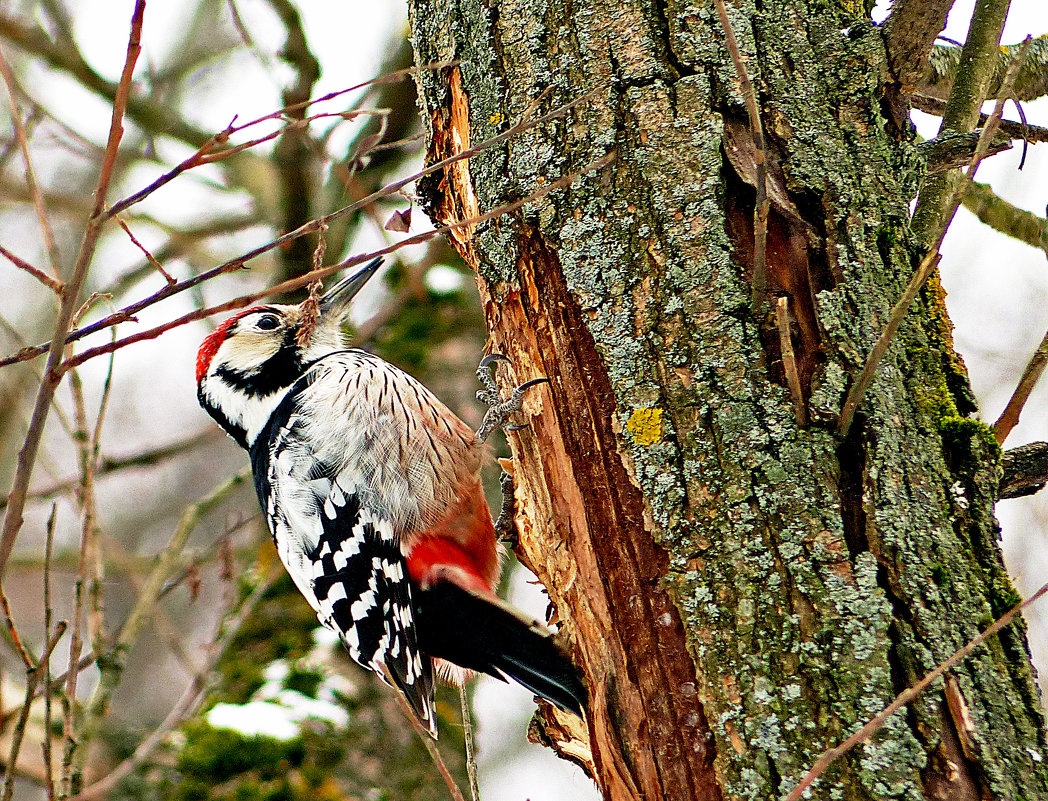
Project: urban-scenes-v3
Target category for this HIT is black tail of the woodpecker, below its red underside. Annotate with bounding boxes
[413,582,586,717]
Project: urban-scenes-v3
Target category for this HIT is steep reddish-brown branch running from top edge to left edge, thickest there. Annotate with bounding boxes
[0,0,146,585]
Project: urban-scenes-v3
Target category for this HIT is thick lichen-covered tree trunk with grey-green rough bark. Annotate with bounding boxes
[411,0,1048,801]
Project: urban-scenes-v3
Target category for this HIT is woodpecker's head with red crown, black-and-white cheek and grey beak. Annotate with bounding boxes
[196,259,383,448]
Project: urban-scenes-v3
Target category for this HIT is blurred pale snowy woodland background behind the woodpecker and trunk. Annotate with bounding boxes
[0,0,1048,801]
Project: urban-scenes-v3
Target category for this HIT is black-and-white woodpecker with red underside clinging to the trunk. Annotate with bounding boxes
[196,259,586,737]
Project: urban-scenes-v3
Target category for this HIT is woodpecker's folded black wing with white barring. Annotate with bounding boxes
[250,365,436,736]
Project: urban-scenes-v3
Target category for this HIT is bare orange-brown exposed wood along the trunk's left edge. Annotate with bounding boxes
[429,61,721,801]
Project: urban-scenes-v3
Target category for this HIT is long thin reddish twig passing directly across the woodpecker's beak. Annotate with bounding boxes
[63,154,615,369]
